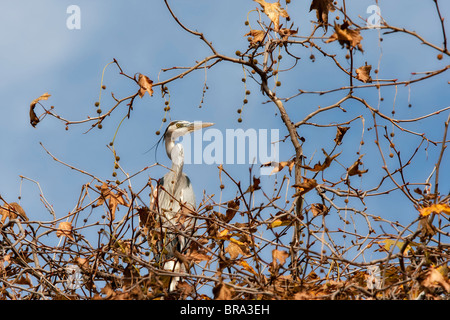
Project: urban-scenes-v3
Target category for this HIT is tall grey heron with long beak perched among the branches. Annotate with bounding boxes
[152,121,213,291]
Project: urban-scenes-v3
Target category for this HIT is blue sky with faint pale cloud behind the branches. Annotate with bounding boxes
[0,0,450,252]
